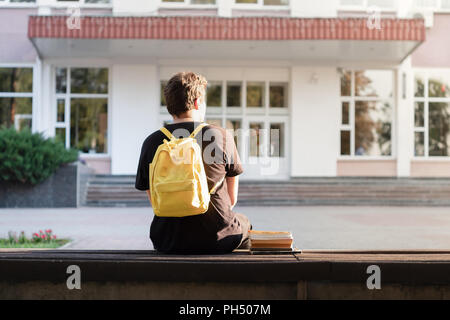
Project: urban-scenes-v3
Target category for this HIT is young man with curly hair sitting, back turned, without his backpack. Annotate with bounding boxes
[135,73,251,253]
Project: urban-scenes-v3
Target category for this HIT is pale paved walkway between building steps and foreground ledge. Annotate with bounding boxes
[0,206,450,250]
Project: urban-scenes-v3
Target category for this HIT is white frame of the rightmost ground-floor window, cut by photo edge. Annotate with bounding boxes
[411,68,450,161]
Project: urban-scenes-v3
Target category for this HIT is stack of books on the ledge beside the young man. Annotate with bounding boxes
[249,230,294,251]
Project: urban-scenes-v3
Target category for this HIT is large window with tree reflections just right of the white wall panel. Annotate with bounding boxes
[340,70,393,157]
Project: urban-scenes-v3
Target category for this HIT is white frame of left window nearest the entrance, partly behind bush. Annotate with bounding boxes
[51,63,112,158]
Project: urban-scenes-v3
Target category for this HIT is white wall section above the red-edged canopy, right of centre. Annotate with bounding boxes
[290,0,339,18]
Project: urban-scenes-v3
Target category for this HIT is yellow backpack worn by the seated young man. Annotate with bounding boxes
[150,123,225,217]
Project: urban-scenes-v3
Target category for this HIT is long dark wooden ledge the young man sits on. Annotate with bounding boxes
[0,250,450,299]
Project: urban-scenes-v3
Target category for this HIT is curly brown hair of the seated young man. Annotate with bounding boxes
[164,71,208,116]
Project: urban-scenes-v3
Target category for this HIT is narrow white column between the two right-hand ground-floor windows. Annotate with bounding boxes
[395,57,414,177]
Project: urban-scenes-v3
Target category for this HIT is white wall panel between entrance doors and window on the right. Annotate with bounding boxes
[291,66,340,177]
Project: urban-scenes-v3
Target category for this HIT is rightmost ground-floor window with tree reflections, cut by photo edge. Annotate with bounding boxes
[414,71,450,157]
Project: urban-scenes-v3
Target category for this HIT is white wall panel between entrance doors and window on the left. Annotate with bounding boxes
[110,64,160,174]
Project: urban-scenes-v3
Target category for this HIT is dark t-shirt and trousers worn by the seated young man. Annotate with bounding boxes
[135,121,243,253]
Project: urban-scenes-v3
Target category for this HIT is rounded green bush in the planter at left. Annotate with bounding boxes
[0,128,78,184]
